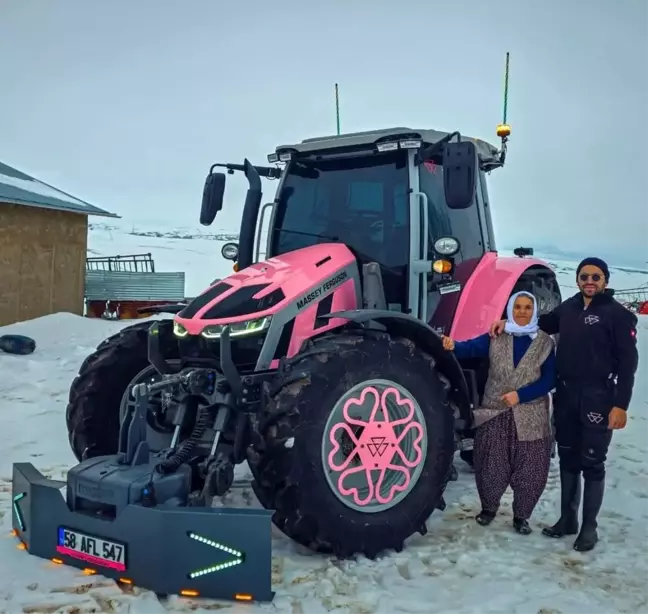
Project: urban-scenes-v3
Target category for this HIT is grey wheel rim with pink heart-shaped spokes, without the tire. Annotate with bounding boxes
[322,379,427,514]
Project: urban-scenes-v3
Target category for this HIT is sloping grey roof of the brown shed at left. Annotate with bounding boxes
[0,162,119,217]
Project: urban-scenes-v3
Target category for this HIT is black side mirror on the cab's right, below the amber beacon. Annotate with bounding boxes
[443,141,479,209]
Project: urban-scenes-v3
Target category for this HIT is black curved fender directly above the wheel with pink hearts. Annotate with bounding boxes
[326,309,472,424]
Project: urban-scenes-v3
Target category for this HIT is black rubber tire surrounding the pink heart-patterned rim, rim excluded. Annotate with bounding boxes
[248,331,454,558]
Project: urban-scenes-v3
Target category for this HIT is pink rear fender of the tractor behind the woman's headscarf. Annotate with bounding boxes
[449,252,550,341]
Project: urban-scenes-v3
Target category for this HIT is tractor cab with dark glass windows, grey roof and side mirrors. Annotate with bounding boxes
[201,128,504,330]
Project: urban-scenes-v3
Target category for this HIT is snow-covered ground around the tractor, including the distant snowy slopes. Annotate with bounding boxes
[0,222,648,614]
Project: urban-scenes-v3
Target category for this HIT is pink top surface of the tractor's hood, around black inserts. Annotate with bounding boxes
[174,243,355,335]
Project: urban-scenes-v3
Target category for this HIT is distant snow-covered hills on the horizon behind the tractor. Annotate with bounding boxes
[88,220,648,297]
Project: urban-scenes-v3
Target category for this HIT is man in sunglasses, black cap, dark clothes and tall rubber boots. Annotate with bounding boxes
[490,258,638,552]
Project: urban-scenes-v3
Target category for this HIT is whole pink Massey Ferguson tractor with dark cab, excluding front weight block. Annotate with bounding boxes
[58,128,561,572]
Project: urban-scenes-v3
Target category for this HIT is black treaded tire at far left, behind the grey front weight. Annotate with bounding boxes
[65,321,167,461]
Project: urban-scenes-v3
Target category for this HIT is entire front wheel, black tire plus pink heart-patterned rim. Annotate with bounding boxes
[248,330,454,558]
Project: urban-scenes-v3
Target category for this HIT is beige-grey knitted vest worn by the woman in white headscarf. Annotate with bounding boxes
[474,331,553,441]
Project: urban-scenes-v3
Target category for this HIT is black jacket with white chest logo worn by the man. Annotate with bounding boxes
[539,290,639,409]
